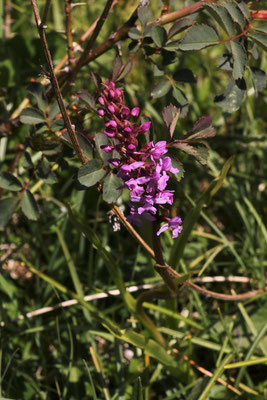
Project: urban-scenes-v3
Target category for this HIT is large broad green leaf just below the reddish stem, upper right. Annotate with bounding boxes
[178,24,219,51]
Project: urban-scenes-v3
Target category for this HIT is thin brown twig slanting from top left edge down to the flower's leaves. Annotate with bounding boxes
[31,0,86,164]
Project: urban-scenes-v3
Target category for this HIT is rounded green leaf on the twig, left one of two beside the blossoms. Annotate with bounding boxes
[78,159,106,187]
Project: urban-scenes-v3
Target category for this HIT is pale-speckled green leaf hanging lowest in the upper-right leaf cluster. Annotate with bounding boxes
[214,78,246,113]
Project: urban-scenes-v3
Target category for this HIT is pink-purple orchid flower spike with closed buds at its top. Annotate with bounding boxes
[97,80,182,238]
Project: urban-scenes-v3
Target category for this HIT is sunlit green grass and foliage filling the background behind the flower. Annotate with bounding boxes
[0,0,267,400]
